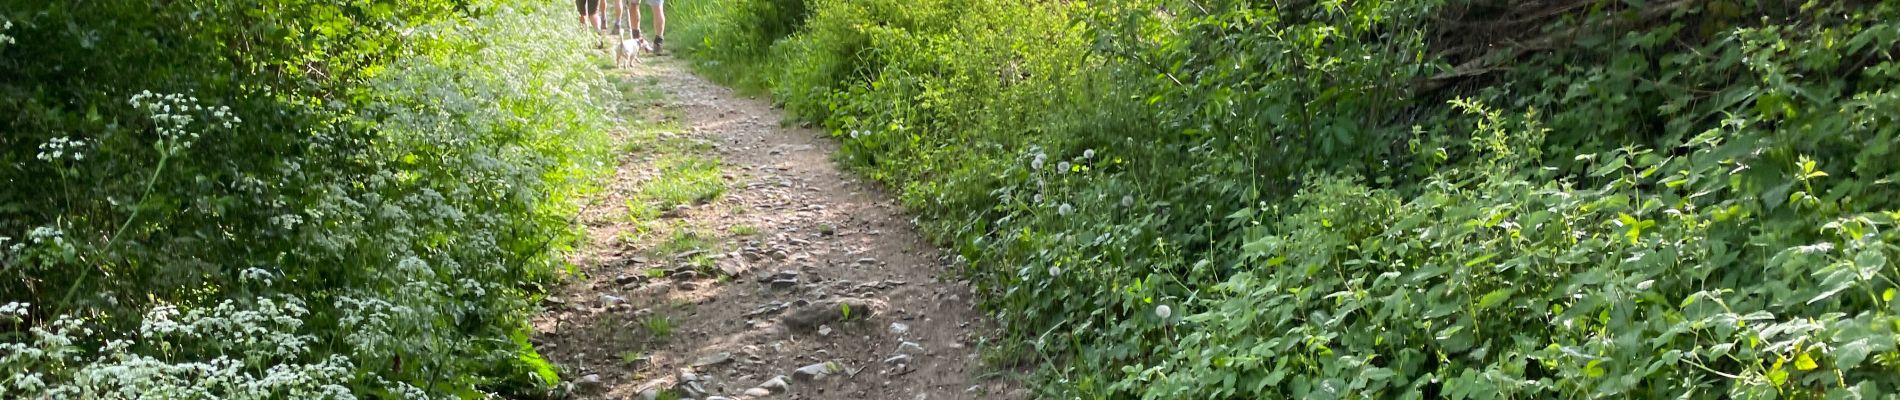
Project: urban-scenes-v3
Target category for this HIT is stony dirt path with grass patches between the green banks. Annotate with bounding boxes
[536,57,1028,400]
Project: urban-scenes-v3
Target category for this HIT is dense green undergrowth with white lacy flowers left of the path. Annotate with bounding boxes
[0,0,614,398]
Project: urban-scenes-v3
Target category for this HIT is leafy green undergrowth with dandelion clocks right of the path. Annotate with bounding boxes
[678,0,1900,398]
